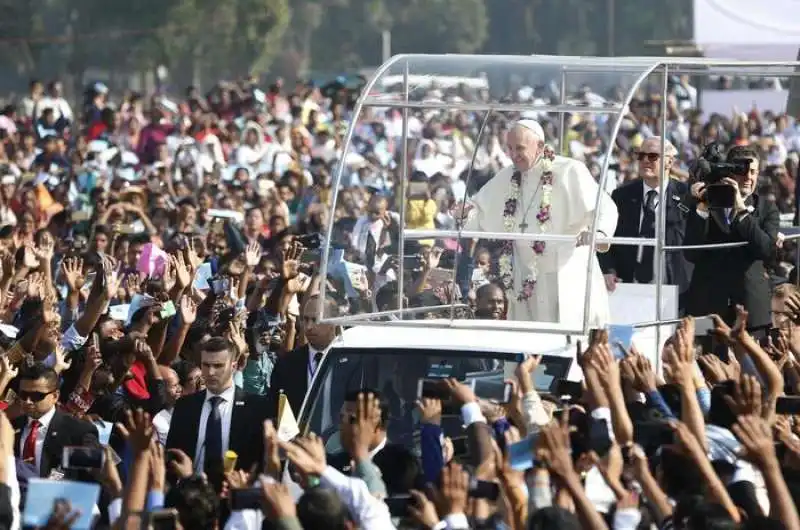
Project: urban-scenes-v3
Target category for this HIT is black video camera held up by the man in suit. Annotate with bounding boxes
[692,142,750,209]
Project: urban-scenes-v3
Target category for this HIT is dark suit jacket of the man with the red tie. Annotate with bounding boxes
[11,410,100,481]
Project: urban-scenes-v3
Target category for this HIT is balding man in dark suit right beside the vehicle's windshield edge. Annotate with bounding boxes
[267,290,338,419]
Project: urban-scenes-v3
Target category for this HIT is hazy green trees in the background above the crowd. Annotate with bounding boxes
[0,0,692,89]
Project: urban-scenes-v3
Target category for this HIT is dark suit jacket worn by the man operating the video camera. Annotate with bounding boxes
[684,195,780,328]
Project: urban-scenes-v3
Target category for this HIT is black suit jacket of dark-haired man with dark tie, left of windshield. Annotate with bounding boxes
[167,387,266,487]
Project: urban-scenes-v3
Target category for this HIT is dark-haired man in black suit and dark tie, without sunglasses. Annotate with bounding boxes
[167,337,266,491]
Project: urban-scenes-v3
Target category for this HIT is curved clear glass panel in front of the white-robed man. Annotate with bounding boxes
[316,55,663,333]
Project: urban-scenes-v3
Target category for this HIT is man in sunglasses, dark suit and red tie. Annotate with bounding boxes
[12,363,99,480]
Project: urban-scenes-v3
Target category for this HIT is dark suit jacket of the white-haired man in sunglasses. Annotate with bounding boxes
[598,179,693,293]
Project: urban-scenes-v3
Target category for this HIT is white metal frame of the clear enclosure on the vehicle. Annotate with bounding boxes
[318,54,800,350]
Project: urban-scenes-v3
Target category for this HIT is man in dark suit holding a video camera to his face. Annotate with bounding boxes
[683,146,780,335]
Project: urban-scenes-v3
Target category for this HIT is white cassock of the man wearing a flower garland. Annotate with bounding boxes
[464,156,617,329]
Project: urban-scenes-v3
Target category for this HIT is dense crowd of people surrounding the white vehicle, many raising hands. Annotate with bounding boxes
[0,66,800,530]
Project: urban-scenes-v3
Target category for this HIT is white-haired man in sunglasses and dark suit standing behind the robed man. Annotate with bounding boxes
[598,137,692,309]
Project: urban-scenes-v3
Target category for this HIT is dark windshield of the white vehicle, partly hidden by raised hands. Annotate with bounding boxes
[300,348,571,453]
